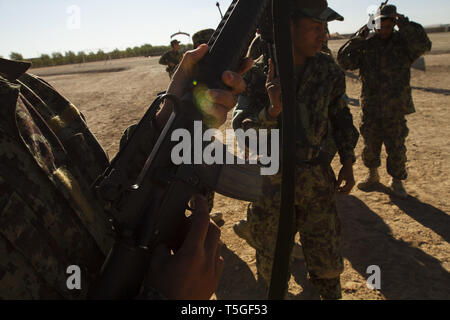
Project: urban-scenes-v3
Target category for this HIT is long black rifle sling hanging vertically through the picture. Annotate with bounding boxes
[268,0,300,300]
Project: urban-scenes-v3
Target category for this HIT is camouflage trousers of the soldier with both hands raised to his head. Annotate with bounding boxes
[360,116,409,180]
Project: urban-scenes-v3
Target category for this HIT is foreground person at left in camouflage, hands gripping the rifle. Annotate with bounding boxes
[0,47,250,299]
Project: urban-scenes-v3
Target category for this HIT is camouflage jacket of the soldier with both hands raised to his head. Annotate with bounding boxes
[338,19,431,119]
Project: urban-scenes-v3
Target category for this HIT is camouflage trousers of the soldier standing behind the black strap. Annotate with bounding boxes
[247,165,344,299]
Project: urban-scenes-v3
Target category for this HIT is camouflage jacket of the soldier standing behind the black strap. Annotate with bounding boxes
[233,52,359,162]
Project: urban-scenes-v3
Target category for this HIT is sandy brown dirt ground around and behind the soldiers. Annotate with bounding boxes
[32,33,450,300]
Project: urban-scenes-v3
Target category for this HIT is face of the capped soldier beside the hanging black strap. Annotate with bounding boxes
[291,18,327,57]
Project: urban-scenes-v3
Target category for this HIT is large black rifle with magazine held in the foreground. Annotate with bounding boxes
[89,0,271,299]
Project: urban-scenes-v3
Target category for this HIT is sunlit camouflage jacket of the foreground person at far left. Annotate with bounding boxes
[0,59,163,299]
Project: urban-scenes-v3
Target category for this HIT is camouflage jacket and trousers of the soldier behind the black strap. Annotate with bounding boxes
[233,53,359,299]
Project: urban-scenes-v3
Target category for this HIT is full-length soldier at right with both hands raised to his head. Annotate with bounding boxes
[338,5,431,198]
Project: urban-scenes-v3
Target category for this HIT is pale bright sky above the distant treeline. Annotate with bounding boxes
[0,0,450,58]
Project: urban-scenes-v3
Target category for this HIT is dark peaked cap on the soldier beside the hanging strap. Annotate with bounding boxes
[291,0,344,22]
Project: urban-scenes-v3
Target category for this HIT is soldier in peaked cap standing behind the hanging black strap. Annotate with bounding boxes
[233,0,359,299]
